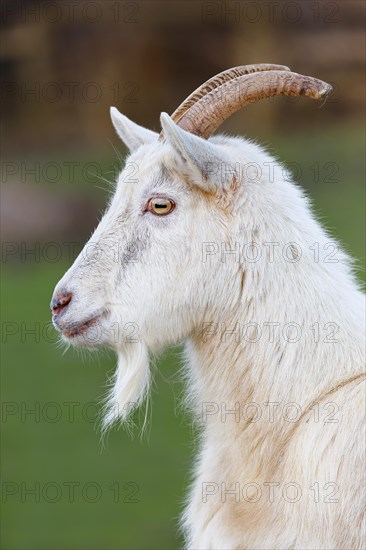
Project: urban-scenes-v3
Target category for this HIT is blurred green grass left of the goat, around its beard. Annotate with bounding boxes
[2,265,191,550]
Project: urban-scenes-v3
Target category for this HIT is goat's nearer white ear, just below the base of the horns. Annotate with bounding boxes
[160,113,236,193]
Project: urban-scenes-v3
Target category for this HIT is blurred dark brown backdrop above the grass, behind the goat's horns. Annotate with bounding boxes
[1,0,365,246]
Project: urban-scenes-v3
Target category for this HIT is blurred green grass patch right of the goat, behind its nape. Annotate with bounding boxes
[272,126,365,281]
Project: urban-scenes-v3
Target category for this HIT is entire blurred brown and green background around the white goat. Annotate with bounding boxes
[1,0,365,550]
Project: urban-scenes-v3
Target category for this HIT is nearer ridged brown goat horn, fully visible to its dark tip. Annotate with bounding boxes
[178,69,332,139]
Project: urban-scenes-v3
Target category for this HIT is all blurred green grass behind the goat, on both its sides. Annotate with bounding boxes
[1,128,364,550]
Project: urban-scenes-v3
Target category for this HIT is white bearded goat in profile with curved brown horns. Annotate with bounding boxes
[51,65,365,550]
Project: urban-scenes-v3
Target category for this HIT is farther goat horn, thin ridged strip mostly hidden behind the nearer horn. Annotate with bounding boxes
[172,63,290,123]
